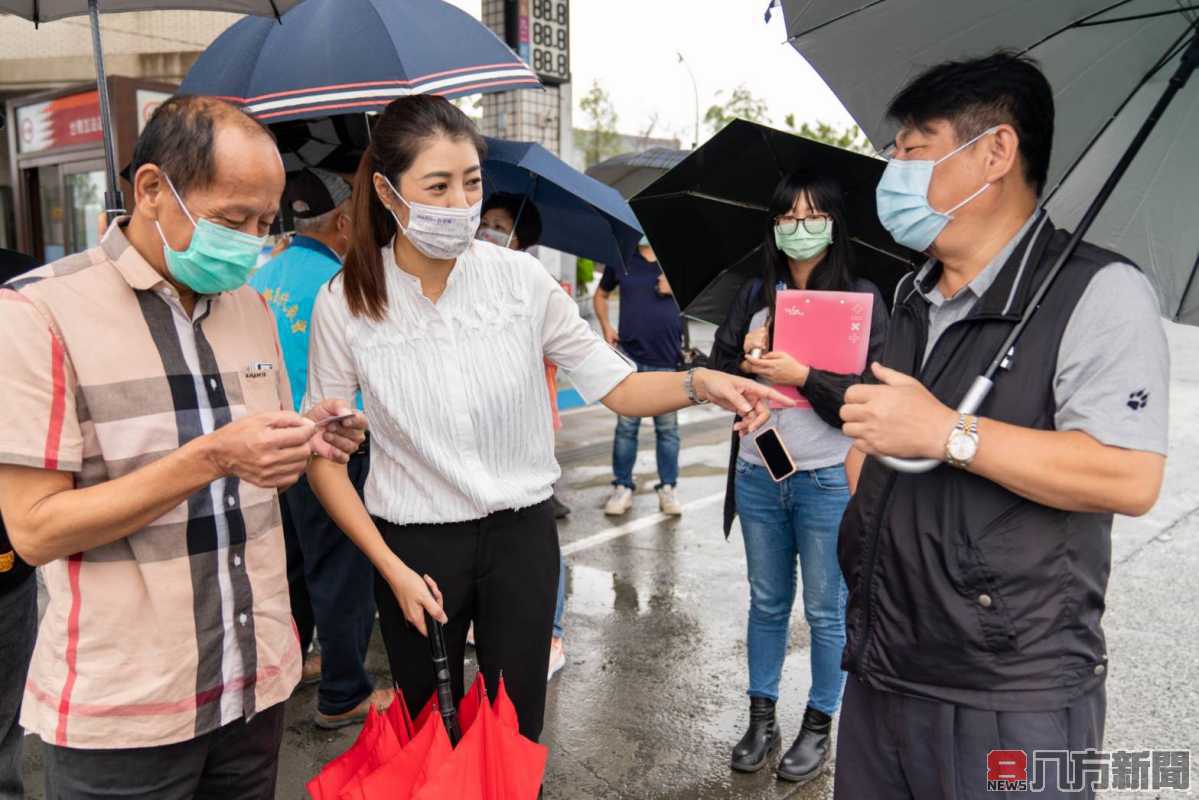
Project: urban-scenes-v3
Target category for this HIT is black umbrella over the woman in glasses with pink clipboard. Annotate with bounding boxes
[632,120,923,324]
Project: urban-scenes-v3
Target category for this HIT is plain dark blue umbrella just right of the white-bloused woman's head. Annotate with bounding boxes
[483,138,643,266]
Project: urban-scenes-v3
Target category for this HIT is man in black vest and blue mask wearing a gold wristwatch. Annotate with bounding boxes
[836,53,1169,800]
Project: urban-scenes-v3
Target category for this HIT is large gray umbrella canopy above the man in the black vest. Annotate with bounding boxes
[782,0,1199,324]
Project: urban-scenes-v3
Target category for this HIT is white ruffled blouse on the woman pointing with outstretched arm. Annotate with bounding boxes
[306,241,634,524]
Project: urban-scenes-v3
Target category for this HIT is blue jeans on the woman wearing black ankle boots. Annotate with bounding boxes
[736,459,849,716]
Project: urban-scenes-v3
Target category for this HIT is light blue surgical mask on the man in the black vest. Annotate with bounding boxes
[874,126,999,252]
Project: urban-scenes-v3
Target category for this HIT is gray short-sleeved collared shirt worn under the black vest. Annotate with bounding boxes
[911,217,1170,456]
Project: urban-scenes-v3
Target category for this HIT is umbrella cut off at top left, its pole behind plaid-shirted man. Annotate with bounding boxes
[0,0,301,218]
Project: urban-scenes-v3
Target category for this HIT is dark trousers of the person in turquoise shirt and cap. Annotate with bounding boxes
[279,452,374,715]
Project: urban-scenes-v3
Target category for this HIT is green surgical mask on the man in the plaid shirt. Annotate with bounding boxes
[153,173,266,294]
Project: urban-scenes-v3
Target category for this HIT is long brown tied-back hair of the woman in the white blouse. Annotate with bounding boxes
[342,95,487,321]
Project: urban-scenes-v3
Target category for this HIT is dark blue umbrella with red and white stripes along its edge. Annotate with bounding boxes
[179,0,541,122]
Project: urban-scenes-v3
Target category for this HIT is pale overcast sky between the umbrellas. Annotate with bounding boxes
[450,0,852,146]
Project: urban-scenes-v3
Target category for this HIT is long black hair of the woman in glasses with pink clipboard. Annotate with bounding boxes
[761,172,855,333]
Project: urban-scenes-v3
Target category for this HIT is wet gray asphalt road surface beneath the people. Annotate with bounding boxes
[16,326,1199,800]
